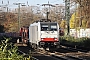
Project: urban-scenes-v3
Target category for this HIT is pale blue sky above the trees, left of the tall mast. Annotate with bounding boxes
[0,0,64,8]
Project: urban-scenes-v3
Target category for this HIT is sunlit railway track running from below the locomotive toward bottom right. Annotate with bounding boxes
[31,47,86,60]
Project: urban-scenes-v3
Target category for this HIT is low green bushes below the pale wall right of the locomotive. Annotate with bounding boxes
[60,36,90,47]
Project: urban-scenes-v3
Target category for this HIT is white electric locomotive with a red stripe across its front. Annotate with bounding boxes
[29,19,60,49]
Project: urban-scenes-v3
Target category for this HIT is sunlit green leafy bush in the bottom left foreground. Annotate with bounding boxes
[0,38,30,60]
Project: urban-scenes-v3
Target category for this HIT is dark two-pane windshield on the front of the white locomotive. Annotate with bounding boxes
[41,23,57,31]
